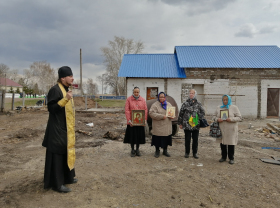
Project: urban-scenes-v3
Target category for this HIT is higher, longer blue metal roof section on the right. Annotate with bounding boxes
[175,46,280,68]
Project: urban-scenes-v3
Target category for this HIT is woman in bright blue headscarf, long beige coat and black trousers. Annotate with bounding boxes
[213,95,242,164]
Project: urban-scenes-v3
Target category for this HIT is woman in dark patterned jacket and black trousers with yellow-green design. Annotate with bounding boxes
[178,89,205,159]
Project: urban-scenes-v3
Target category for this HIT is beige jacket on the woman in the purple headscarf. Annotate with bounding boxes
[149,101,172,136]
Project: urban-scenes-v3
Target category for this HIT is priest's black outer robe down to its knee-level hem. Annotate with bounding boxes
[42,84,68,154]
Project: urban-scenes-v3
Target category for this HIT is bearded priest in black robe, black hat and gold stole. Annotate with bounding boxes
[42,66,78,193]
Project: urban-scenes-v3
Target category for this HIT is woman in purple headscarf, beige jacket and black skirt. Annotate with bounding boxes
[149,92,172,158]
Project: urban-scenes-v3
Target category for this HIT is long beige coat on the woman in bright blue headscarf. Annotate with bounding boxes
[213,105,242,145]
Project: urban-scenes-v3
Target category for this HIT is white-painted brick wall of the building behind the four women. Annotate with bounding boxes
[127,78,270,118]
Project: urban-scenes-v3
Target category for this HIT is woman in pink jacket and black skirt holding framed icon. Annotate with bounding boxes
[123,87,148,157]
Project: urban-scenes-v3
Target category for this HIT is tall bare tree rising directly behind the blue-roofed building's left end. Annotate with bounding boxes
[101,36,144,95]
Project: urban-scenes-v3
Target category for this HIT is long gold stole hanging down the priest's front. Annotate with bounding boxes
[58,83,76,170]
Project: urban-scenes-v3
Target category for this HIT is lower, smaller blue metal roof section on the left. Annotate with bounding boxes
[118,54,186,78]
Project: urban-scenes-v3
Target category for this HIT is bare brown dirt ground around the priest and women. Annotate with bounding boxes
[0,100,280,208]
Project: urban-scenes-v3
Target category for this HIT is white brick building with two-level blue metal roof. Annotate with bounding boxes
[118,46,280,118]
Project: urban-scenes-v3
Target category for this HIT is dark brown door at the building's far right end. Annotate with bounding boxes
[267,88,280,116]
